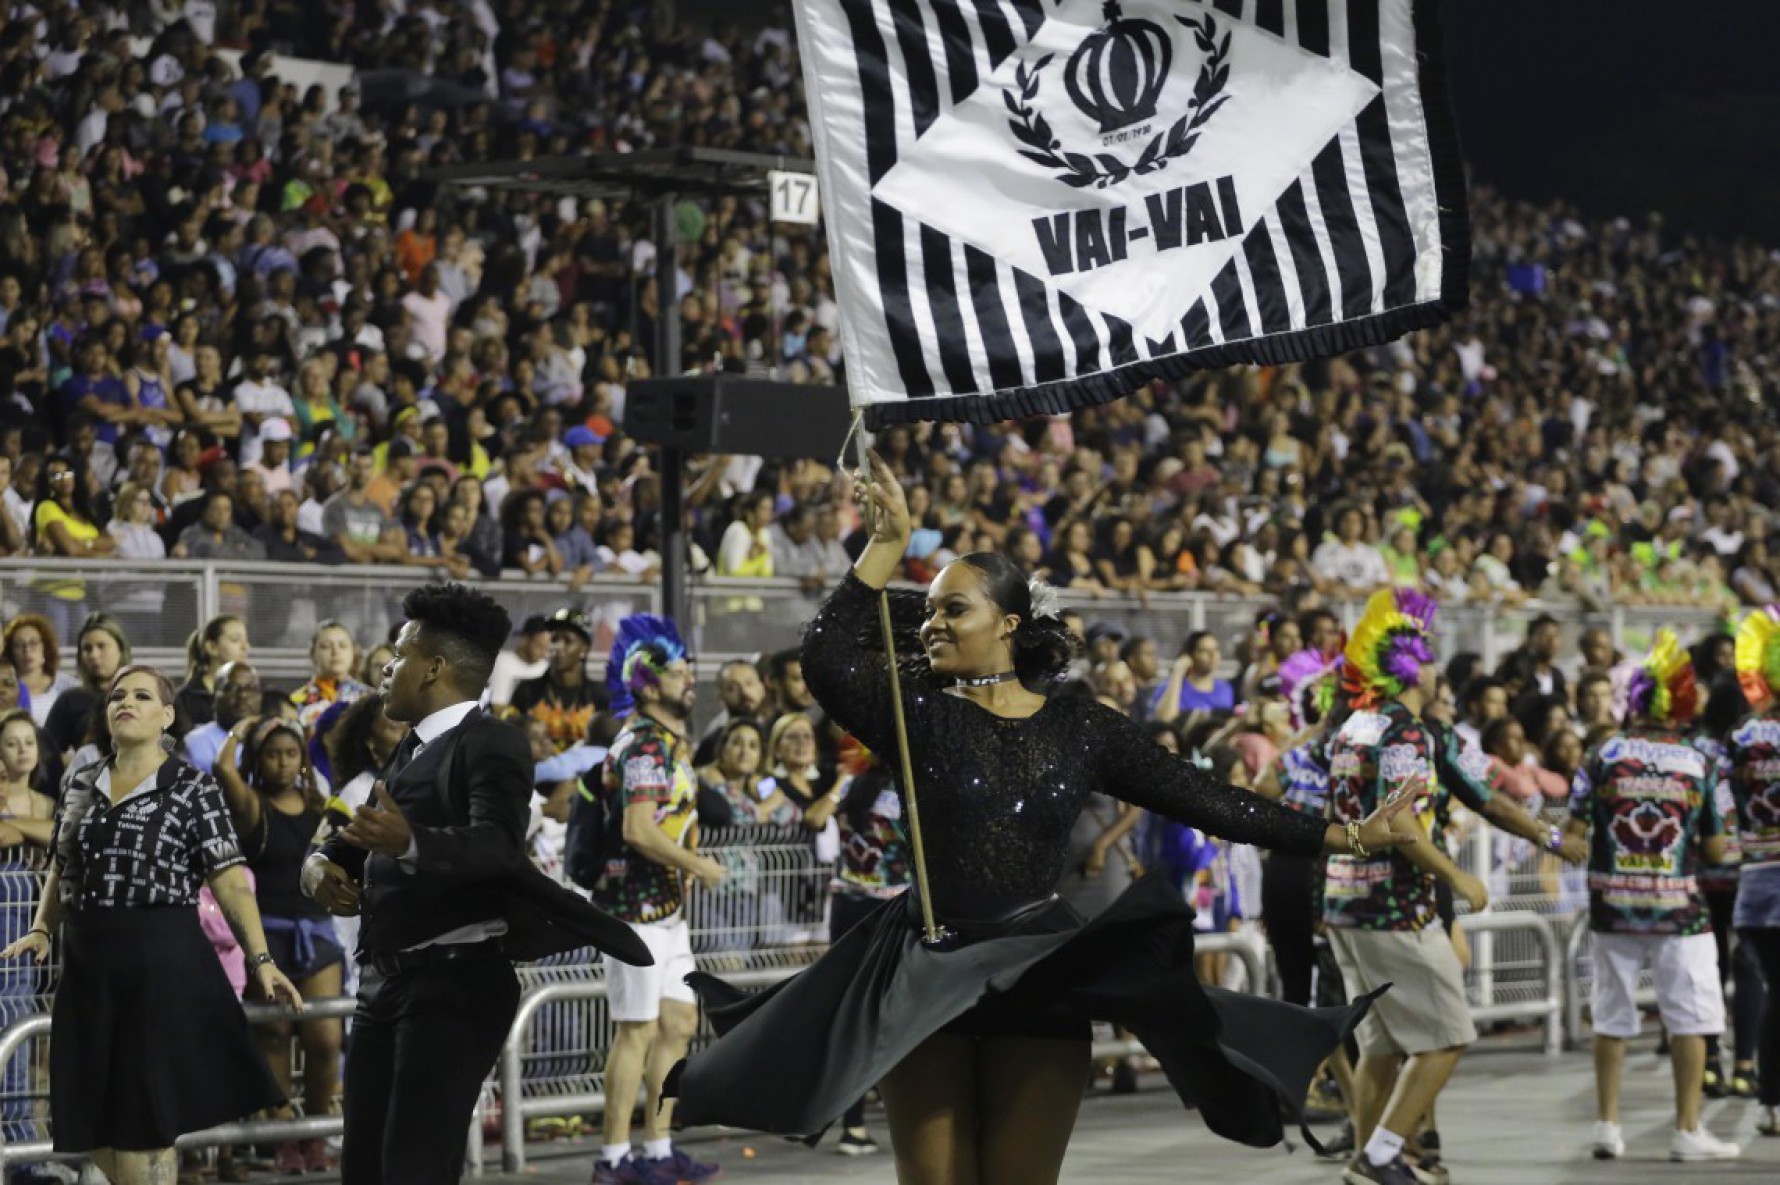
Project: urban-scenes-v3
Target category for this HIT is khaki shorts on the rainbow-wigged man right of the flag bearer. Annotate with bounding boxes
[1330,925,1477,1057]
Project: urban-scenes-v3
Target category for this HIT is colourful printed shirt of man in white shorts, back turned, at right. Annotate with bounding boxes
[1570,730,1725,936]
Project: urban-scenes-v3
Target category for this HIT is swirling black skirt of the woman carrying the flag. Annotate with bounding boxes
[668,877,1372,1148]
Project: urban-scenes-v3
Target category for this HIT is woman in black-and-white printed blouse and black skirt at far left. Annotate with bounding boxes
[0,665,303,1185]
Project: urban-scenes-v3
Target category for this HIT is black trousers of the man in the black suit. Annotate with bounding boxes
[340,950,520,1185]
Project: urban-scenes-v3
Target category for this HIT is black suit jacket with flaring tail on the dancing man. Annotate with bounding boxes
[320,710,653,966]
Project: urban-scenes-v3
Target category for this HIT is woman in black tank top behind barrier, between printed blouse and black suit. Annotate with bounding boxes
[215,705,356,1173]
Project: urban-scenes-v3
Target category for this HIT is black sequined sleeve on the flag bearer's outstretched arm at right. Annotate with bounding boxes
[1084,703,1326,856]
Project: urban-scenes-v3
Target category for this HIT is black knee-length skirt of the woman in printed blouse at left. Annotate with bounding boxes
[50,906,285,1153]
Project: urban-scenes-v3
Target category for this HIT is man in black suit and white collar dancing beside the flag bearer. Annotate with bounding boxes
[303,584,648,1185]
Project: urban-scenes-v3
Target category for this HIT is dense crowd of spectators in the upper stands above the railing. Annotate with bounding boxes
[0,4,1780,633]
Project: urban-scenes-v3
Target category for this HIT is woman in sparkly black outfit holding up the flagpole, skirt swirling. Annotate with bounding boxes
[676,459,1410,1185]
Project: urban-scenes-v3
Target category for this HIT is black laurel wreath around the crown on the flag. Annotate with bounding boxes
[1002,12,1230,189]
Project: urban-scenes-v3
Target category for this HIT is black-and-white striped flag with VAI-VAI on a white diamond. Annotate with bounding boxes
[796,0,1469,425]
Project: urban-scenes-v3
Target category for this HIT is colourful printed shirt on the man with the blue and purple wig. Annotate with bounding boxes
[593,712,698,922]
